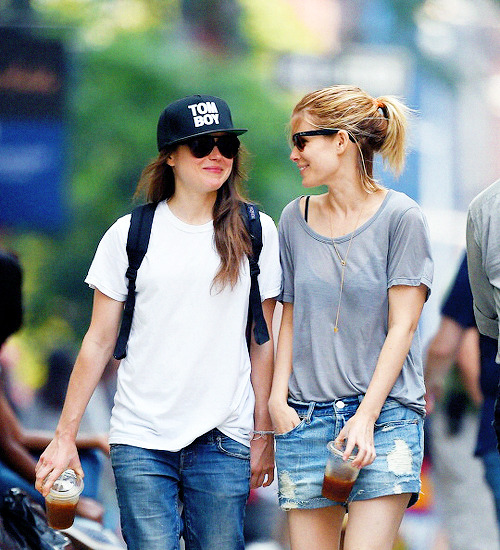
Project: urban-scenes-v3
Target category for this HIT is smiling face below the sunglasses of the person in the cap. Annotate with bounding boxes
[167,133,233,198]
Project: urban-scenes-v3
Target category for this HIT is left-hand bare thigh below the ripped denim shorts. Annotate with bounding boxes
[287,506,345,550]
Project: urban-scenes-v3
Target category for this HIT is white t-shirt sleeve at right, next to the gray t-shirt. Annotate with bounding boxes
[258,212,281,301]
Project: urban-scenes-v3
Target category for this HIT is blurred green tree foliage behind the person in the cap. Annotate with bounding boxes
[3,19,300,358]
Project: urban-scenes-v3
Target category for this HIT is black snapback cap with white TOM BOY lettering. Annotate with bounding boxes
[156,95,247,151]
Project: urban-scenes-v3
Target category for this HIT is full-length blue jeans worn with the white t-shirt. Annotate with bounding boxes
[111,429,250,550]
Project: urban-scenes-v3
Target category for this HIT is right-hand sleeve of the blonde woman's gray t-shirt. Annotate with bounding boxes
[387,206,433,297]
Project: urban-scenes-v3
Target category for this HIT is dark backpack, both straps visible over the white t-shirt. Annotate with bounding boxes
[113,202,269,359]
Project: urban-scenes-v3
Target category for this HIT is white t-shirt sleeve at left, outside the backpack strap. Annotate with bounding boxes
[85,215,130,302]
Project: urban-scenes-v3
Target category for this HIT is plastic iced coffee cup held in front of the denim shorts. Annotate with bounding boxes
[321,441,359,503]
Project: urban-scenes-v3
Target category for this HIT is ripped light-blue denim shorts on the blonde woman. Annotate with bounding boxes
[276,396,424,510]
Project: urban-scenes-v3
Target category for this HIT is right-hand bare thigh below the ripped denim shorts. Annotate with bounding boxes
[344,493,410,550]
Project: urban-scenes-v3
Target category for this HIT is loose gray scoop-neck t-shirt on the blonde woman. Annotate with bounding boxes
[279,190,433,414]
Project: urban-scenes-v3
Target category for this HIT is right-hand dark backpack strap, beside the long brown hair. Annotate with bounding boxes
[241,203,269,345]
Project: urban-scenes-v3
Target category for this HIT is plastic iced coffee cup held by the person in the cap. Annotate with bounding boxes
[45,470,83,529]
